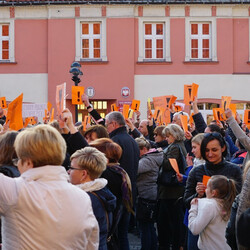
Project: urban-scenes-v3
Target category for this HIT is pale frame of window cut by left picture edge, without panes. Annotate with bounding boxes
[0,19,15,62]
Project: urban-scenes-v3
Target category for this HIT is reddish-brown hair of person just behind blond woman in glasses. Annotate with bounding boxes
[89,138,122,163]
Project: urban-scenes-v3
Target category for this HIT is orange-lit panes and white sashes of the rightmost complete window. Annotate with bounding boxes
[190,23,211,59]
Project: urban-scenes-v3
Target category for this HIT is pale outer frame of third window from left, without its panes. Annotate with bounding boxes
[138,17,171,62]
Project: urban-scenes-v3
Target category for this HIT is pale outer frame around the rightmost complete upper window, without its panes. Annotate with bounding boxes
[185,17,217,62]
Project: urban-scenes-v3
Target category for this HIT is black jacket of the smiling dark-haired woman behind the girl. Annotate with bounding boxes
[184,160,242,208]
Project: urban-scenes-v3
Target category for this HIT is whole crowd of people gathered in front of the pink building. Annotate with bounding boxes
[0,95,250,250]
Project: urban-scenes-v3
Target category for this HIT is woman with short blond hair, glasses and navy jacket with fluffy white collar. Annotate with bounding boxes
[68,147,116,250]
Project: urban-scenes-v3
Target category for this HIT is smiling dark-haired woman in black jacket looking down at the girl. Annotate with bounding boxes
[184,132,242,249]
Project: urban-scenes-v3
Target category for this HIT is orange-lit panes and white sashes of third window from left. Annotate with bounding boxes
[144,23,165,59]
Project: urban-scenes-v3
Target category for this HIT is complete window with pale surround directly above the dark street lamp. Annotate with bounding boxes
[75,18,107,61]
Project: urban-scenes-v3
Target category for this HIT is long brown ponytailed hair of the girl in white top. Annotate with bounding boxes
[209,175,236,221]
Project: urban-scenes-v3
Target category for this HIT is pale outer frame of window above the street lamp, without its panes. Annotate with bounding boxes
[75,18,107,61]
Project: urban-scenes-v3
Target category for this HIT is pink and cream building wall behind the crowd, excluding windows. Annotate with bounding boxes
[0,5,250,119]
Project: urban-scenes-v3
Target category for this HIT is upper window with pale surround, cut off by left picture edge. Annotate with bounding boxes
[0,20,15,62]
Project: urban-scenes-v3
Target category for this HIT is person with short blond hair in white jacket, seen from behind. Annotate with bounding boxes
[0,125,99,250]
